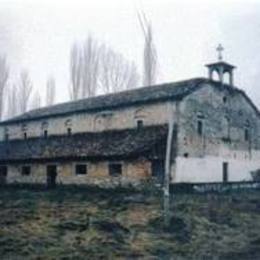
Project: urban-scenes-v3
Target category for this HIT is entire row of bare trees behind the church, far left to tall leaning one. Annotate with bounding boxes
[0,12,157,120]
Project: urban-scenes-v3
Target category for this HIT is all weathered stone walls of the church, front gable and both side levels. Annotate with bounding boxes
[0,81,260,184]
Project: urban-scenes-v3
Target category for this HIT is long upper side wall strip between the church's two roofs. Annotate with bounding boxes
[0,102,173,140]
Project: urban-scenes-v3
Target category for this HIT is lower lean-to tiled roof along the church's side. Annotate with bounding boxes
[0,125,167,163]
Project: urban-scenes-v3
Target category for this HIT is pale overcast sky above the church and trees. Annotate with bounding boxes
[0,0,260,106]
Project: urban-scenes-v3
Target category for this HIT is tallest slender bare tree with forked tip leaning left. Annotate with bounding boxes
[137,9,158,86]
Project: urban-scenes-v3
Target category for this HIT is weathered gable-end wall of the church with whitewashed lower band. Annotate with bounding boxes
[172,85,260,182]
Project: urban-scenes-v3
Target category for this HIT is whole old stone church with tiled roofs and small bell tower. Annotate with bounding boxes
[0,49,260,186]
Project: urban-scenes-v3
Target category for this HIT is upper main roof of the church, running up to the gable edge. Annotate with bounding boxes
[0,78,260,125]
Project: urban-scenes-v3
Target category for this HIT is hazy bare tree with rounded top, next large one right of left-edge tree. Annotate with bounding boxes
[18,70,33,113]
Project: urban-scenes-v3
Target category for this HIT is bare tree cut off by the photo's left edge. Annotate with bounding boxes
[0,56,9,120]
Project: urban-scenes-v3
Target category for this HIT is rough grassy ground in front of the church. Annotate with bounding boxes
[0,185,260,259]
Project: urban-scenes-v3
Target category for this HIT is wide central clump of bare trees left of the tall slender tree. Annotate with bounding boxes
[70,35,139,100]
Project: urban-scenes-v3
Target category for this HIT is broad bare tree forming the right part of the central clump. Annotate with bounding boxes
[99,46,139,93]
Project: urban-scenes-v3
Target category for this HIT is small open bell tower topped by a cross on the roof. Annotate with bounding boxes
[206,44,236,86]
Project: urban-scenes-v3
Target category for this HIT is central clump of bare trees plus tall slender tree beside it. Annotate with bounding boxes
[70,11,158,100]
